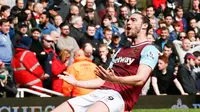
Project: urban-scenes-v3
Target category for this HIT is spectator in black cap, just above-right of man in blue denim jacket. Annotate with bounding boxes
[48,5,60,24]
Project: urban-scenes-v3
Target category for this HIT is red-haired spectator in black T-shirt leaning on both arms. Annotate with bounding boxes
[149,56,187,95]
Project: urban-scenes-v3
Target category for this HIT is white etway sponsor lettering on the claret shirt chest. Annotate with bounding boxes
[115,57,135,65]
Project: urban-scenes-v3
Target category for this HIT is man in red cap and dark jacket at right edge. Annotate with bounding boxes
[178,53,200,95]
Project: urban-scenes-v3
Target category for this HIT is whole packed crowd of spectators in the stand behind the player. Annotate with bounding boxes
[0,0,200,97]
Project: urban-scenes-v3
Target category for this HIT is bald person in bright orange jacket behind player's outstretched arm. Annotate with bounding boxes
[63,49,98,97]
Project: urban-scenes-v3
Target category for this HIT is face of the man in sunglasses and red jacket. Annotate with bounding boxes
[43,35,54,49]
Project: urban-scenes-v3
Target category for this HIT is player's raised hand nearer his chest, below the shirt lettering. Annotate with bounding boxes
[95,66,118,82]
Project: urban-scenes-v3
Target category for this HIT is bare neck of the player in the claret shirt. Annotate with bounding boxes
[132,32,147,45]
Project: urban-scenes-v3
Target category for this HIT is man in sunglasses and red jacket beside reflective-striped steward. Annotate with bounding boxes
[42,35,67,93]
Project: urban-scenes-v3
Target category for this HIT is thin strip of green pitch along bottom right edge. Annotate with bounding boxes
[131,108,200,112]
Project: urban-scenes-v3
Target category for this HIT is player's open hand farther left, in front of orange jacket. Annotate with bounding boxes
[58,72,77,86]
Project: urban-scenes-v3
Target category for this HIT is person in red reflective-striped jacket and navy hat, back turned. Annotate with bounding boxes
[12,36,49,88]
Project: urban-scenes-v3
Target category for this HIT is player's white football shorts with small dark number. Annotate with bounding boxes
[68,89,124,112]
